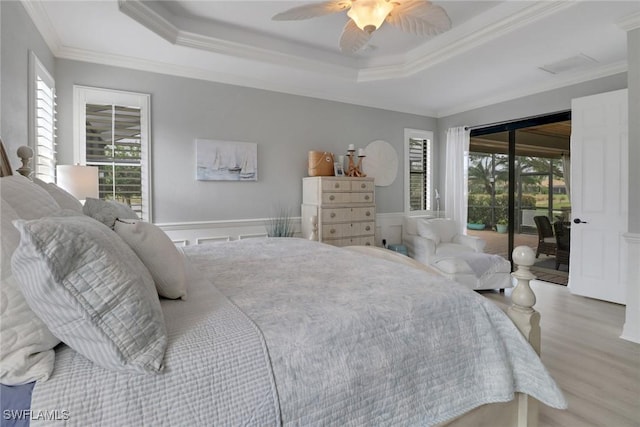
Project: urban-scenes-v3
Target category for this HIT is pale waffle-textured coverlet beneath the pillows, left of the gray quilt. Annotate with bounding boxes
[31,273,280,426]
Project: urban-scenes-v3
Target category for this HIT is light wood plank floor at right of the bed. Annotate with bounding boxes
[483,281,640,427]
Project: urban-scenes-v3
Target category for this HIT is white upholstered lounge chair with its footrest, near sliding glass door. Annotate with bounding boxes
[402,217,512,290]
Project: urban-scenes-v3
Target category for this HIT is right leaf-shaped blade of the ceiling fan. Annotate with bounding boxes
[386,0,451,36]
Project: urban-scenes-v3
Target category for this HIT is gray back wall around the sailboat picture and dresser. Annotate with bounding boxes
[55,60,436,223]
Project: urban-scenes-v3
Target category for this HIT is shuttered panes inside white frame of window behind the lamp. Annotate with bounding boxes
[85,103,144,218]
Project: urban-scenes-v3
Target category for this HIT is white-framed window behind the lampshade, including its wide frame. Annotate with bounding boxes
[74,86,151,221]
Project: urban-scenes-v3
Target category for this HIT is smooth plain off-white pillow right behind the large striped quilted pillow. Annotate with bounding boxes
[114,220,187,299]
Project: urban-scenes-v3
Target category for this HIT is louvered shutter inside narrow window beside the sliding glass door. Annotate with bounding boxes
[409,138,431,211]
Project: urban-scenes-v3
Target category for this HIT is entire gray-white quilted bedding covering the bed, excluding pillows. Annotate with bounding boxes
[32,239,566,426]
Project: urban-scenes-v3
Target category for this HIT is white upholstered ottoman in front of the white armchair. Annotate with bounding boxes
[431,253,513,290]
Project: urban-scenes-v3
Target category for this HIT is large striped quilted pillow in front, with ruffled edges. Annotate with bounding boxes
[12,216,167,372]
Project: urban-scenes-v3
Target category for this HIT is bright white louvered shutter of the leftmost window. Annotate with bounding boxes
[34,74,56,182]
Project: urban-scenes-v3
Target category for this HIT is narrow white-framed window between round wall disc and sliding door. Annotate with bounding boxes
[405,129,433,214]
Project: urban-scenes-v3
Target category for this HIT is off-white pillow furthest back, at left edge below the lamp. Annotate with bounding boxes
[0,175,60,219]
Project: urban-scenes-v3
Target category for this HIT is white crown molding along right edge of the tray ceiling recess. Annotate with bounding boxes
[358,0,578,82]
